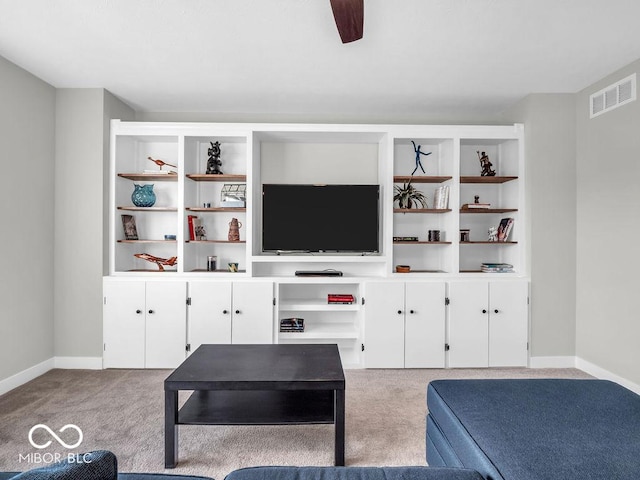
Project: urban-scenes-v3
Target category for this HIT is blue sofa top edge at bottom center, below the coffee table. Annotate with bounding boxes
[225,467,483,480]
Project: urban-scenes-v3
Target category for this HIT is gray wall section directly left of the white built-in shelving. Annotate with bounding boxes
[54,89,133,358]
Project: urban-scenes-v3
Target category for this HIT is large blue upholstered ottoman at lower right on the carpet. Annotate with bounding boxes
[427,379,640,480]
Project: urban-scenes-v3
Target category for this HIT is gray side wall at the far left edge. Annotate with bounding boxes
[0,57,55,380]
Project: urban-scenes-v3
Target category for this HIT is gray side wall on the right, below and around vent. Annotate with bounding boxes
[576,61,640,384]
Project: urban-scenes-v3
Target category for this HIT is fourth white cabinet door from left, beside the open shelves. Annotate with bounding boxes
[231,282,273,344]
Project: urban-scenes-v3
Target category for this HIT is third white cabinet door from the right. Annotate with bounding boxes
[404,282,445,368]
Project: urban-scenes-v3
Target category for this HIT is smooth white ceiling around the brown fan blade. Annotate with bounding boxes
[0,0,640,118]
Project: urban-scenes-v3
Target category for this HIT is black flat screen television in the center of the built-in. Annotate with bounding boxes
[262,184,380,253]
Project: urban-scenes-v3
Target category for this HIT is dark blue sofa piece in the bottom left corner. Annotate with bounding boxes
[12,450,118,480]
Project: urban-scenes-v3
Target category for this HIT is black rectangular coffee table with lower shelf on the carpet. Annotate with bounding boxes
[164,345,345,468]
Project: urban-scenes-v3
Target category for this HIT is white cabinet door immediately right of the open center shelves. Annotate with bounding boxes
[364,282,405,368]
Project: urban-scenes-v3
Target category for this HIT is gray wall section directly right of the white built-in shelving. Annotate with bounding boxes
[504,94,576,357]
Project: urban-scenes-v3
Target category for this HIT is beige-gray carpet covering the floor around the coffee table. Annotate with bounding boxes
[0,369,589,480]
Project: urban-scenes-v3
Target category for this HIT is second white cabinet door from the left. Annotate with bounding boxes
[145,282,187,368]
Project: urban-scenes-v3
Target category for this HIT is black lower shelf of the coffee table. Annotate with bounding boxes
[177,390,335,425]
